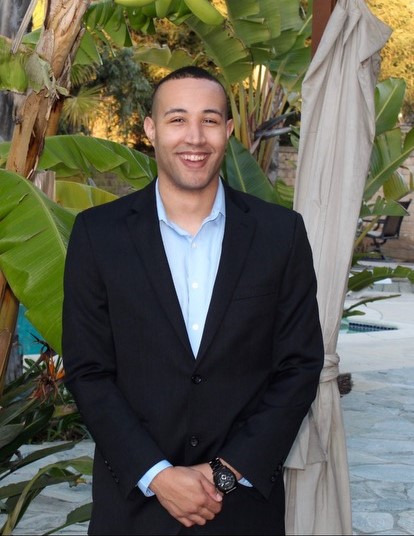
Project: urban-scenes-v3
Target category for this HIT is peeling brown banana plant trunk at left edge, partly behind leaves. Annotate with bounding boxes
[0,0,91,392]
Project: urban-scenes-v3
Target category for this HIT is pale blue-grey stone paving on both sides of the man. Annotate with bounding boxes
[3,268,414,535]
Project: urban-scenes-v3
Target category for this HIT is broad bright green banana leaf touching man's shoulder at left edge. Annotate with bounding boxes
[0,170,74,353]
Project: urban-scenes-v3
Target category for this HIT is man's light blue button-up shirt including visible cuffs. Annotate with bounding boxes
[138,181,249,497]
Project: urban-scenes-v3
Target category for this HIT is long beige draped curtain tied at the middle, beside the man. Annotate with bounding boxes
[285,0,391,535]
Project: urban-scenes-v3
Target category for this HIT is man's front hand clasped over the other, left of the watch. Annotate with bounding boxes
[150,464,223,527]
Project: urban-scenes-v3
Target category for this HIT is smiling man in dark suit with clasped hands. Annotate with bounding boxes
[63,67,323,535]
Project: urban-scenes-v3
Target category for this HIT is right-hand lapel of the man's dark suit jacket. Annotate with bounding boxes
[197,188,256,362]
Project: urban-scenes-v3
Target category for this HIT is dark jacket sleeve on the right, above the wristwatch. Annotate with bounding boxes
[219,214,324,497]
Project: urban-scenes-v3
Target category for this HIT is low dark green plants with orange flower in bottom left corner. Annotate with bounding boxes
[0,346,92,535]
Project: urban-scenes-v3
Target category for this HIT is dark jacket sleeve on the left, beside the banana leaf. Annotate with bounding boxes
[62,213,165,496]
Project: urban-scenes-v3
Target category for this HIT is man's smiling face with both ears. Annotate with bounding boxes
[144,78,233,191]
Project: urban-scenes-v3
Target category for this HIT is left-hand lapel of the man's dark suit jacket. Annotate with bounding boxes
[127,181,192,355]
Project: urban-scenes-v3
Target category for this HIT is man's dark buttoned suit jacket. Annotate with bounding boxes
[63,184,323,535]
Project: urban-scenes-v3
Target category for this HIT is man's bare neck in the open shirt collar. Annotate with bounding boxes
[158,179,219,236]
